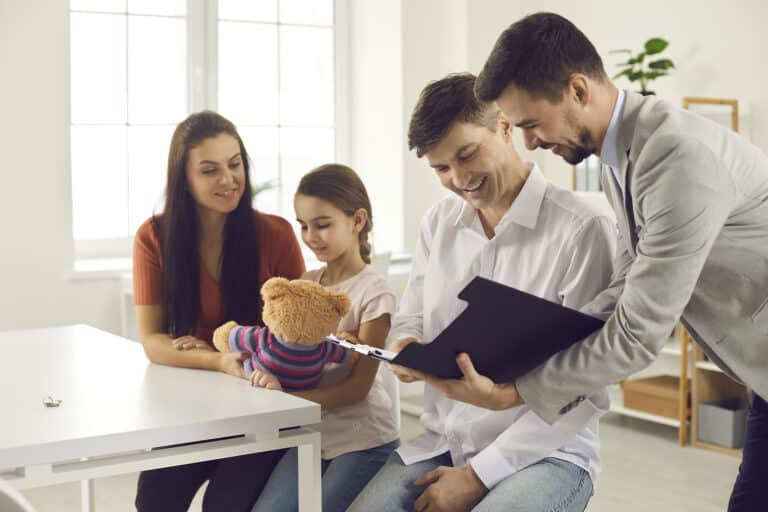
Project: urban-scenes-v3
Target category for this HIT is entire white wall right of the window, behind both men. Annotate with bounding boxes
[348,0,768,251]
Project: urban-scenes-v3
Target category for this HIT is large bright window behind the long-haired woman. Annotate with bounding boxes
[70,0,337,258]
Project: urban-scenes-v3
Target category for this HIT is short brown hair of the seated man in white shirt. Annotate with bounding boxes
[408,73,498,158]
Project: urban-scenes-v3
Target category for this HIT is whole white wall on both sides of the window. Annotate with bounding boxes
[0,0,768,332]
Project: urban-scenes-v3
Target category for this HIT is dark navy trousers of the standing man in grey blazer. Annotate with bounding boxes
[728,393,768,512]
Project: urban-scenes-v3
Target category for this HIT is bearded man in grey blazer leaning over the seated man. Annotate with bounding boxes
[420,13,768,510]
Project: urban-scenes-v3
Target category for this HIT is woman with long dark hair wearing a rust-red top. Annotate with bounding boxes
[133,111,305,512]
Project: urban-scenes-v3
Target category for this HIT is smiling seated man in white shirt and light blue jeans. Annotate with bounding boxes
[350,73,616,512]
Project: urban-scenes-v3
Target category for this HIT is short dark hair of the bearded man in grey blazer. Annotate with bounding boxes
[475,12,608,103]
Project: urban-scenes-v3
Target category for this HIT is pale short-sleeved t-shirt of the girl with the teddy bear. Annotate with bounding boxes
[301,265,400,459]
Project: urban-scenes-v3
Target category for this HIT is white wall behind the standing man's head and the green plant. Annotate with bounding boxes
[468,0,768,185]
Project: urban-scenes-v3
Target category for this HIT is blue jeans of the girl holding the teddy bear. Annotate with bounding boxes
[251,439,400,512]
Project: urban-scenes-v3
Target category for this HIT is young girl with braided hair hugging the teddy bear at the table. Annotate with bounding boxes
[251,164,400,512]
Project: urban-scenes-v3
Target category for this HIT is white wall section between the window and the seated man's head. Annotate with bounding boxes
[348,0,467,251]
